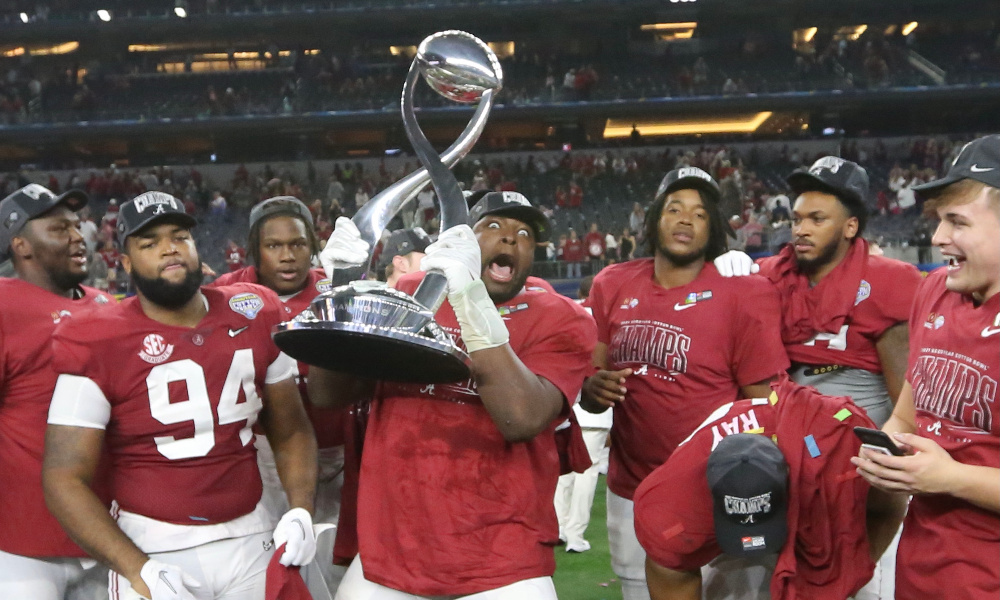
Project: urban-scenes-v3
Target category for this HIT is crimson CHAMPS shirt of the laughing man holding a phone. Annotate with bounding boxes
[896,268,1000,600]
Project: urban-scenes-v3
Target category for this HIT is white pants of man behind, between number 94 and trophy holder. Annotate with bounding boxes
[254,435,347,600]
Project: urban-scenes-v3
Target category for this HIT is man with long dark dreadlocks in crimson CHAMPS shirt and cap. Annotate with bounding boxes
[581,167,788,600]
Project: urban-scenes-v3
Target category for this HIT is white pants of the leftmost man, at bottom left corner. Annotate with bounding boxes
[0,548,108,600]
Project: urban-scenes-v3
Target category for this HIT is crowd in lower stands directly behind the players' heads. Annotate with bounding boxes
[3,137,966,292]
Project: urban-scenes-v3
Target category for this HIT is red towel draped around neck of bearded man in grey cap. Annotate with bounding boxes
[760,239,868,344]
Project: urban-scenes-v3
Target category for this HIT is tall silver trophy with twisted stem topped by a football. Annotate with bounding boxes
[273,31,503,383]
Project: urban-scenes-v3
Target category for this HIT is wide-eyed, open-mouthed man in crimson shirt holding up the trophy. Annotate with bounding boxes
[309,192,595,600]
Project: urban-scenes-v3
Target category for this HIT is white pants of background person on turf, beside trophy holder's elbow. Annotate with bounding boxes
[555,428,609,546]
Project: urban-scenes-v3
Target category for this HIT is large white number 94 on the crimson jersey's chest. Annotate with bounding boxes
[146,348,264,460]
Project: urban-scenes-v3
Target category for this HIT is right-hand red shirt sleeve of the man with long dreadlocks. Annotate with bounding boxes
[732,276,791,386]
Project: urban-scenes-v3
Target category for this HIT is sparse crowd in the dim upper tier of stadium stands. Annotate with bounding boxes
[0,25,1000,124]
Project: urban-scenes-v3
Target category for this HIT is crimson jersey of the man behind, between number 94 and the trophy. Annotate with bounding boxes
[211,267,347,448]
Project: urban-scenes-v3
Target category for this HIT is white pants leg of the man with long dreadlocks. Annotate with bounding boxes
[608,488,649,600]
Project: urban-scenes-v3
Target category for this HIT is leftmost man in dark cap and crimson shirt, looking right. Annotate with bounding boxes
[0,184,114,600]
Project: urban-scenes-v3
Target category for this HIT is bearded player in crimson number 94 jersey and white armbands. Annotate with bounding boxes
[42,192,316,600]
